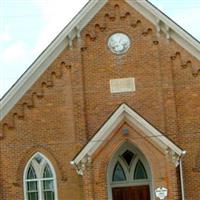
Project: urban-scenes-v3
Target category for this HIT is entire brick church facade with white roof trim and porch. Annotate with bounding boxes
[0,0,200,200]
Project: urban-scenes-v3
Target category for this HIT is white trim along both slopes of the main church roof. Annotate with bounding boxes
[0,0,200,120]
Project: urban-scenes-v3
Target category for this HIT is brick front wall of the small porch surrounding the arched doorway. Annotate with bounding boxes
[83,121,179,200]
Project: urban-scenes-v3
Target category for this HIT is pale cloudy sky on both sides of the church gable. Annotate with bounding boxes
[0,0,200,98]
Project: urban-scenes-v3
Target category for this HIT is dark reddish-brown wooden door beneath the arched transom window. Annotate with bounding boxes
[112,185,150,200]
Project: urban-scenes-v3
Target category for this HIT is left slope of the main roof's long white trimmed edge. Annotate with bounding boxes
[0,0,108,120]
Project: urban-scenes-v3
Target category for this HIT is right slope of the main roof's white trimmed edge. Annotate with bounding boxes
[125,0,200,60]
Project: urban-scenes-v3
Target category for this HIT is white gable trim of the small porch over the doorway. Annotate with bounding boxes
[71,104,185,174]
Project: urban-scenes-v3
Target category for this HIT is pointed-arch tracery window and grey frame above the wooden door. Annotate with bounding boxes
[107,142,151,200]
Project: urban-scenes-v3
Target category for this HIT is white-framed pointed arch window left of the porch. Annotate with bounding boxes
[24,153,57,200]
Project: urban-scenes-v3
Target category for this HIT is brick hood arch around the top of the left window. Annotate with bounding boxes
[13,146,67,187]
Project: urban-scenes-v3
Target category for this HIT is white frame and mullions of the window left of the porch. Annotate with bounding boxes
[23,152,58,200]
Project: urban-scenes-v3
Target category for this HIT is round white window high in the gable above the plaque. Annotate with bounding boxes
[108,32,131,55]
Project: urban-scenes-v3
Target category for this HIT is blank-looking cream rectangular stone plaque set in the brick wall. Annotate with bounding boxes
[110,78,135,93]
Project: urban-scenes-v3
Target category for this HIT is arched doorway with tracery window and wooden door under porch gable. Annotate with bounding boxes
[108,142,151,200]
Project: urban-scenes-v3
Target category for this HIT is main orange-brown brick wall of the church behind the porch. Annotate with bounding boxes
[0,0,200,200]
